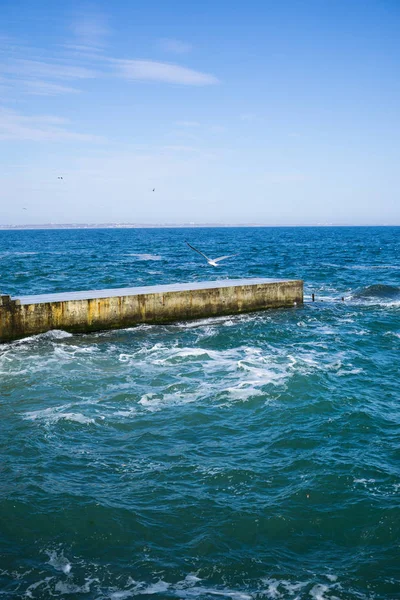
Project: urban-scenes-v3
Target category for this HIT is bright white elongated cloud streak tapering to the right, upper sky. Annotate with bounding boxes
[115,60,218,86]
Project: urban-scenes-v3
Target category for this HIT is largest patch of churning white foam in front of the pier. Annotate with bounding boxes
[116,343,293,412]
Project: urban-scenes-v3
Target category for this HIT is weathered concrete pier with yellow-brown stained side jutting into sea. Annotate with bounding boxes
[0,278,303,342]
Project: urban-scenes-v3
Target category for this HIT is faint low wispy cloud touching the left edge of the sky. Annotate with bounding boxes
[0,107,104,142]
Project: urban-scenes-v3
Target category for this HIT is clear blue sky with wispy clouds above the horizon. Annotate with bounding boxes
[0,0,400,225]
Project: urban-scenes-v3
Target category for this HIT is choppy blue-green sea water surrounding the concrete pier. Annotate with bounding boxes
[0,227,400,600]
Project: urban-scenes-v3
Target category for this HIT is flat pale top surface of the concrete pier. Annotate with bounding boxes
[12,277,297,304]
